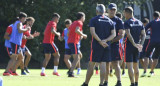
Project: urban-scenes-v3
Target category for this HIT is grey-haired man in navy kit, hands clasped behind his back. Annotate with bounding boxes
[82,4,116,86]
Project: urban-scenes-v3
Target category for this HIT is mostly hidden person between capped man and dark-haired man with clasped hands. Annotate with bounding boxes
[116,12,126,76]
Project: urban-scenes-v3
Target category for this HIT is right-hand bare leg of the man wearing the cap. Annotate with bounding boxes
[112,61,121,86]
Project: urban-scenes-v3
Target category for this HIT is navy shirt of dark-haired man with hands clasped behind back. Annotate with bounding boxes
[124,18,145,44]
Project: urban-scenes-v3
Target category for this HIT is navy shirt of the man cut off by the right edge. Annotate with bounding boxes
[145,18,160,43]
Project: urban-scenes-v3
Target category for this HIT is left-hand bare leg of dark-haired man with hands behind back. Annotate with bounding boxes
[127,62,134,85]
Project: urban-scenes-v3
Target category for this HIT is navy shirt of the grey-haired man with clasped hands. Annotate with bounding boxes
[89,15,115,46]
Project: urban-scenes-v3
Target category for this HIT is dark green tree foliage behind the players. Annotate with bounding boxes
[0,0,151,68]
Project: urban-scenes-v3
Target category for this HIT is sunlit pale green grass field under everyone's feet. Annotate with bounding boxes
[0,69,160,86]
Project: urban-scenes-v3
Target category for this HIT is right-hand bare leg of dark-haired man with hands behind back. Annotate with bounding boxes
[133,62,139,86]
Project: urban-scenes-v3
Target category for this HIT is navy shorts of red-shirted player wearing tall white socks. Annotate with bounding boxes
[43,43,58,54]
